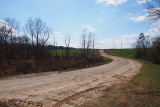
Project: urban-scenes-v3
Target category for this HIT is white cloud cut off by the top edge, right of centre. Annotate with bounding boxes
[97,0,127,5]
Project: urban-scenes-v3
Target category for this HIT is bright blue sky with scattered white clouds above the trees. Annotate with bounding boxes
[0,0,157,49]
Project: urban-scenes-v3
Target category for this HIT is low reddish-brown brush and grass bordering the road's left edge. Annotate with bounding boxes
[0,49,112,78]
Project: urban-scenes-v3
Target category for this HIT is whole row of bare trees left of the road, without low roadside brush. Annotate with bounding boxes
[0,18,96,75]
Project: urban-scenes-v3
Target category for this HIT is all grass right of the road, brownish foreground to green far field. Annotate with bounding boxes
[81,49,160,107]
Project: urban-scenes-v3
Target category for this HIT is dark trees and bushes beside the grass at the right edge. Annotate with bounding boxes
[133,33,160,64]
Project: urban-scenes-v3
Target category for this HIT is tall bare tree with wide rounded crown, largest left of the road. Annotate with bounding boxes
[25,18,51,72]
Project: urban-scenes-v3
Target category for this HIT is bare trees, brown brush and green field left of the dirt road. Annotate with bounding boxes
[0,18,110,77]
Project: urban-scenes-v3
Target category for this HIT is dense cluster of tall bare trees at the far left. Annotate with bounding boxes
[0,18,51,63]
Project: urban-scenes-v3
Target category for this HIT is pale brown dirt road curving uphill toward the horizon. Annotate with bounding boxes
[0,50,141,107]
